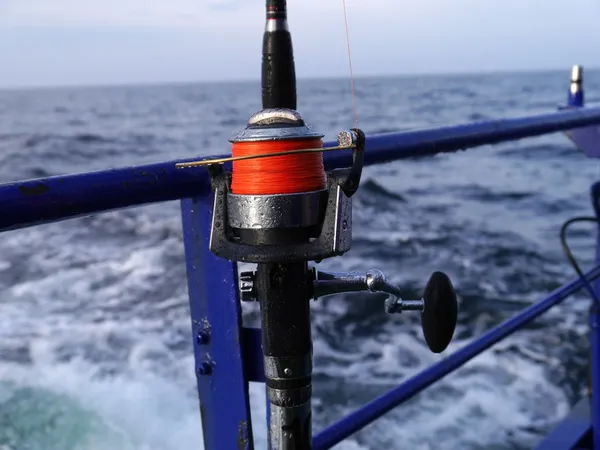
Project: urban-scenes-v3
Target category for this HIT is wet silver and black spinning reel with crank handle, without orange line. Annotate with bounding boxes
[185,108,458,353]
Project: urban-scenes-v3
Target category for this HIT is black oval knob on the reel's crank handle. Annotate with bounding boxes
[421,272,458,353]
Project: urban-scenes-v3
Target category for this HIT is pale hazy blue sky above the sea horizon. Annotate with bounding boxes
[0,0,600,88]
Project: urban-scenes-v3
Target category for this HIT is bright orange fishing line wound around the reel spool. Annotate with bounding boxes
[231,139,327,195]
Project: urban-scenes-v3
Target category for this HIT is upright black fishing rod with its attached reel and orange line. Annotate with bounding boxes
[180,0,458,450]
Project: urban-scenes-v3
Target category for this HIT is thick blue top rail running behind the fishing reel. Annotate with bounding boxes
[0,107,600,231]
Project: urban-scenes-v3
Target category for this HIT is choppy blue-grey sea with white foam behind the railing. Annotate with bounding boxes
[0,70,600,450]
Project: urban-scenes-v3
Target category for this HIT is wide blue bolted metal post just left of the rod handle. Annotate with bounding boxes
[181,195,254,450]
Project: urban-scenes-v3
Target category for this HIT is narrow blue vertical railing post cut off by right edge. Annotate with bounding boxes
[589,182,600,450]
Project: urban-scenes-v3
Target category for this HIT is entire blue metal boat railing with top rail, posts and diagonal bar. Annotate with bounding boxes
[0,69,600,450]
